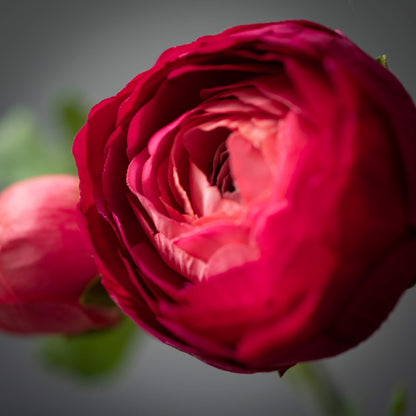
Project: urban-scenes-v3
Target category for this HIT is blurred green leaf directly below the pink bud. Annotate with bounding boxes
[41,317,138,380]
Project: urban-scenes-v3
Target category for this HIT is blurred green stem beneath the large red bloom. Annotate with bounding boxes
[288,363,356,416]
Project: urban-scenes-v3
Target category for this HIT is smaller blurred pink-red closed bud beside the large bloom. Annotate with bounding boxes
[0,175,119,334]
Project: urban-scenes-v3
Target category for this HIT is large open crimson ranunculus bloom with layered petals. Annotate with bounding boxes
[74,21,416,372]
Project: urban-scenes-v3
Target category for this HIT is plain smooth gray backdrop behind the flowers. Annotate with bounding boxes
[0,0,416,416]
